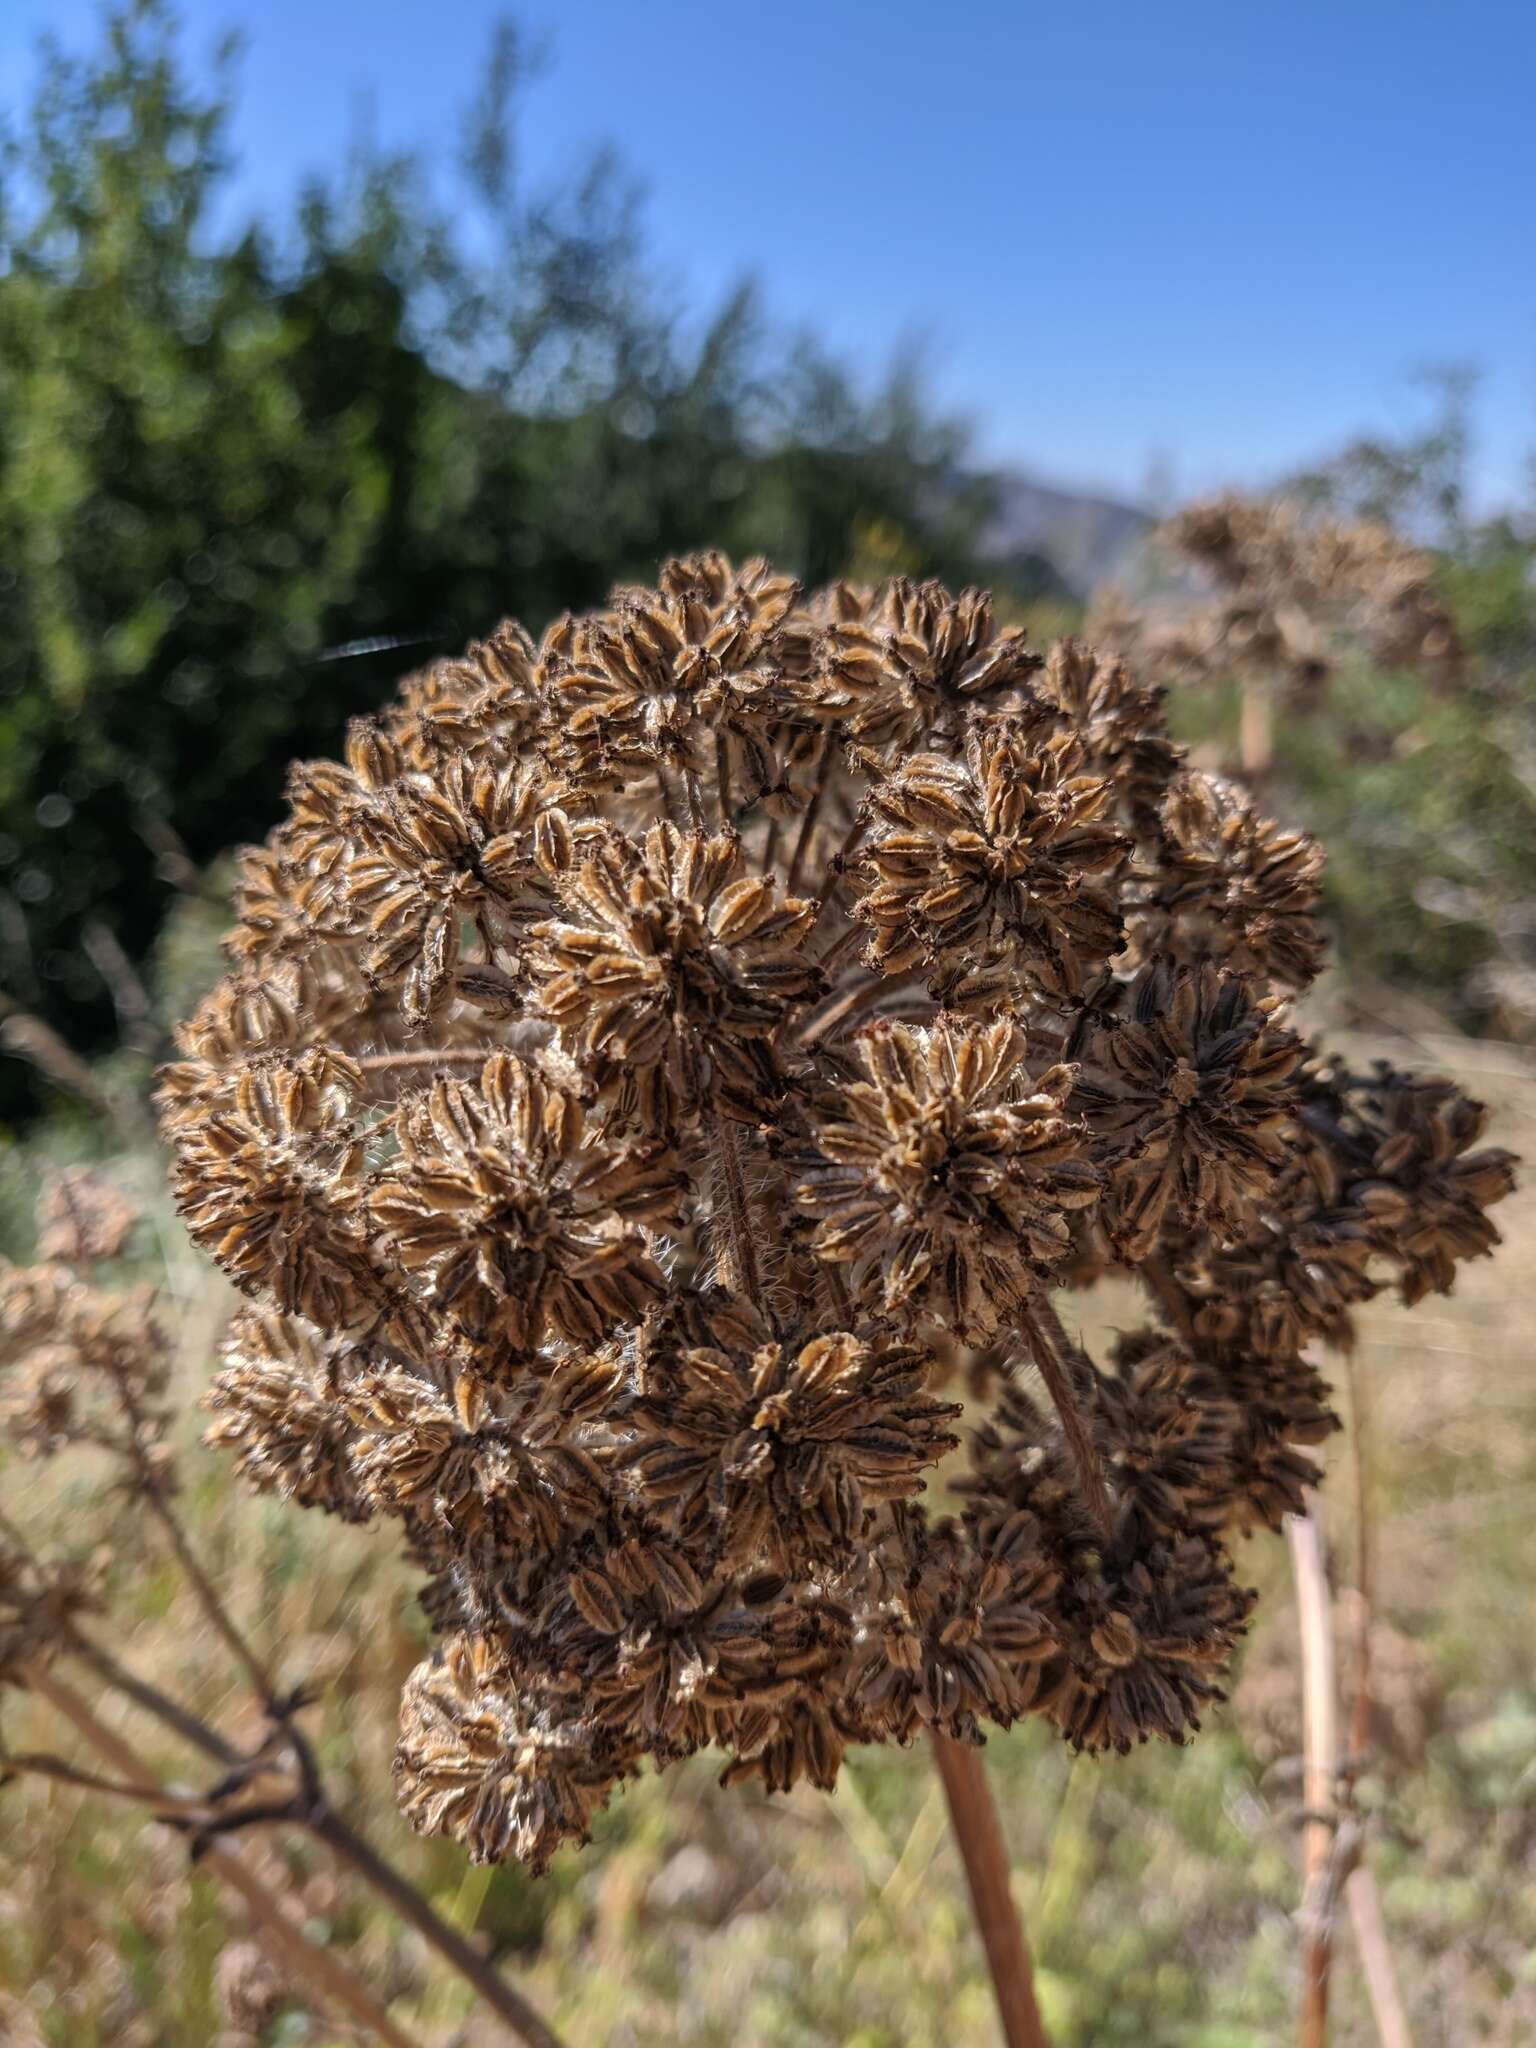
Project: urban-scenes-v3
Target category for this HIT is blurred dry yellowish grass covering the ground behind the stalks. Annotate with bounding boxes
[0,1042,1536,2048]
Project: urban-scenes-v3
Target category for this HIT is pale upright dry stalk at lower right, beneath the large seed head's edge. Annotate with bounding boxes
[1286,1501,1339,2048]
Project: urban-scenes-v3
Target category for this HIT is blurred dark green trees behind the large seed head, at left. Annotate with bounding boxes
[0,0,1003,1118]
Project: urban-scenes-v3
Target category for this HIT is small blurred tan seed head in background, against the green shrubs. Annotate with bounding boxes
[1090,496,1460,702]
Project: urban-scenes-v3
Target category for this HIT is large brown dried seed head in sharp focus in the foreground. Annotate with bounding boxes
[162,555,1509,1868]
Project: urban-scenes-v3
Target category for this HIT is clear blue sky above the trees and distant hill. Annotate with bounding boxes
[0,0,1536,506]
